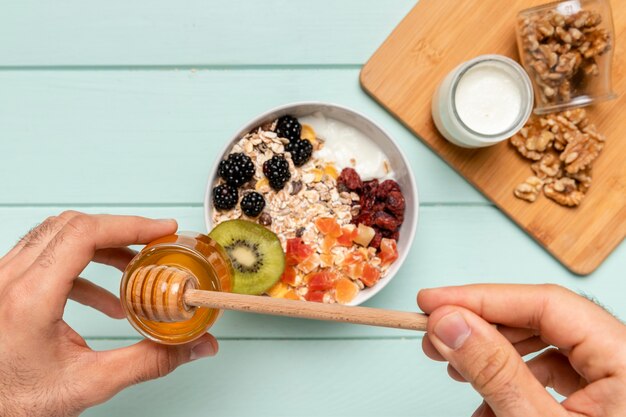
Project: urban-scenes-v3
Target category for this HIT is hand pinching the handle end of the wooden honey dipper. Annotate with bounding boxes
[417,285,626,417]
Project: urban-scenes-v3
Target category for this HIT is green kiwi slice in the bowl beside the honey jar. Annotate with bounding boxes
[209,220,285,295]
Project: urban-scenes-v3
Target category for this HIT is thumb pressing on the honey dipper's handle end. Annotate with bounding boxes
[427,306,565,417]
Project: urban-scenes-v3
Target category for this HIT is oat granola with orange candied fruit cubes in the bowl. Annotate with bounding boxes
[212,117,397,303]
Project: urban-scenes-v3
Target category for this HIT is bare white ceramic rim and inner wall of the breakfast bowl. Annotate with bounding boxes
[204,102,419,305]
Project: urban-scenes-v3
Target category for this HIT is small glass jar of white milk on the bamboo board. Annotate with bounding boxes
[432,55,534,148]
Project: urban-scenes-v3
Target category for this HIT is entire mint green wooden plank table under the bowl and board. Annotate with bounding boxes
[0,0,626,417]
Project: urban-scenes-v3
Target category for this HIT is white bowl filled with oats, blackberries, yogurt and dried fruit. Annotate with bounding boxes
[204,102,419,305]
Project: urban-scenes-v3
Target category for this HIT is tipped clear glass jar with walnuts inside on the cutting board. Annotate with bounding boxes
[517,0,617,114]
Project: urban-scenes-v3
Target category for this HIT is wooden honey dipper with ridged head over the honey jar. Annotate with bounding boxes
[126,265,428,331]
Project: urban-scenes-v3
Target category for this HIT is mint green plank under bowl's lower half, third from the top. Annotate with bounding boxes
[0,206,626,338]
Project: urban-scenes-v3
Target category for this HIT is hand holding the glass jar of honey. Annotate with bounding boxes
[0,212,217,417]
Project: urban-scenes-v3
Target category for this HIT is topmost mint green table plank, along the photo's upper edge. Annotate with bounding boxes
[0,0,415,66]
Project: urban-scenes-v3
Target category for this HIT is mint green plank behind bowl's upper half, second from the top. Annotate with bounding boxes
[0,69,486,205]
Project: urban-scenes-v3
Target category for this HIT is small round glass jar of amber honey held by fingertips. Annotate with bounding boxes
[120,232,234,345]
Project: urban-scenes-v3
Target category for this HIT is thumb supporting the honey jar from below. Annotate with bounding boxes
[84,333,218,404]
